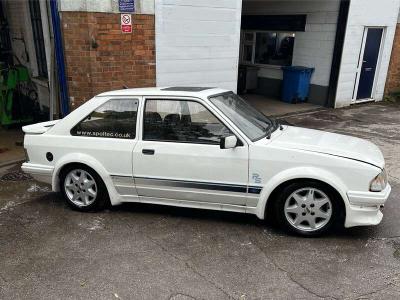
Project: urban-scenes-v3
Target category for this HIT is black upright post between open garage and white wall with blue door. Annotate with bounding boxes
[326,0,350,108]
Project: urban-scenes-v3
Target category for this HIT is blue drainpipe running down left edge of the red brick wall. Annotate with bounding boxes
[50,0,69,117]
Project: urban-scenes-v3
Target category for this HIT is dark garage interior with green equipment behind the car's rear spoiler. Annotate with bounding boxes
[0,0,59,163]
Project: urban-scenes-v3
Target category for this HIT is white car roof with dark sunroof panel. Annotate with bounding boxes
[96,86,230,98]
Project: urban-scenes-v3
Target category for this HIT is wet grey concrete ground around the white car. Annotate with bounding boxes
[0,104,400,300]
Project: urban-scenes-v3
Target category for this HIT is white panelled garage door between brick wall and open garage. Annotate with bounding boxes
[155,0,241,91]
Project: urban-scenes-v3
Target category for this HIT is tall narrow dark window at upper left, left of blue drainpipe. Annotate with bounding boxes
[29,0,48,78]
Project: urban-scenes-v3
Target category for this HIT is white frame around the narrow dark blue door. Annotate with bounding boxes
[351,26,387,104]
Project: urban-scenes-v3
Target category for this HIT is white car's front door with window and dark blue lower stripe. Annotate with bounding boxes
[133,97,248,206]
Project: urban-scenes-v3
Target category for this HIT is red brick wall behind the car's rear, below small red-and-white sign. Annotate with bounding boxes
[61,12,156,109]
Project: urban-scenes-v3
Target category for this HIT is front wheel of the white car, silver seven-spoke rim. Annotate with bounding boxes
[275,181,342,237]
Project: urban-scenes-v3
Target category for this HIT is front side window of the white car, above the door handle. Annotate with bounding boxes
[143,100,232,145]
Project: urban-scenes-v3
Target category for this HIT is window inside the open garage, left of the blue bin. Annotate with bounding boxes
[242,31,295,66]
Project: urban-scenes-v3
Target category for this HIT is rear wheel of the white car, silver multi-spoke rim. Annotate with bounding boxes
[60,165,109,212]
